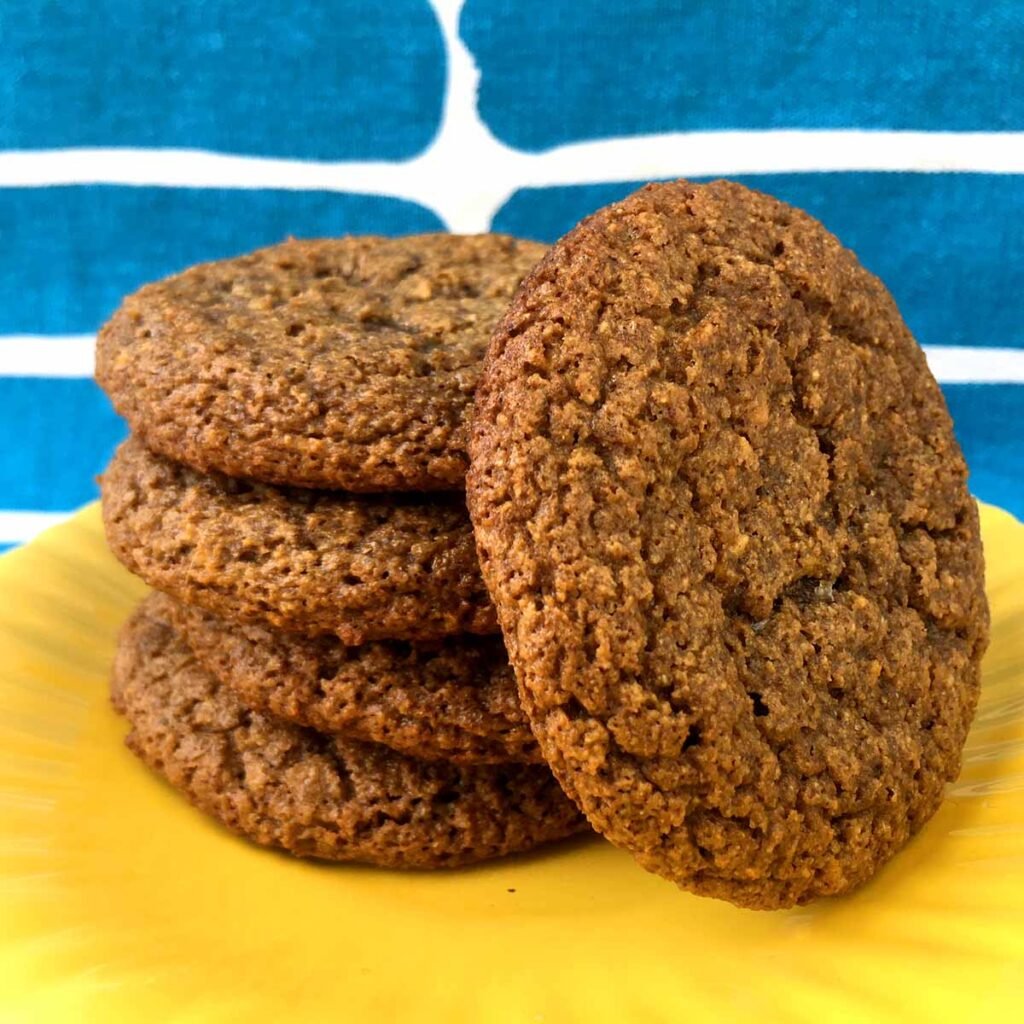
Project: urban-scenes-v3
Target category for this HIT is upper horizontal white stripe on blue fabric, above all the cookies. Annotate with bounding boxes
[0,128,1024,192]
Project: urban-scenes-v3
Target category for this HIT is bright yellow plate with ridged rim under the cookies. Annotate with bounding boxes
[0,499,1024,1024]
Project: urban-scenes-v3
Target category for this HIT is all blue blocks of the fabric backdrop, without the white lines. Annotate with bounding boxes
[0,0,1024,552]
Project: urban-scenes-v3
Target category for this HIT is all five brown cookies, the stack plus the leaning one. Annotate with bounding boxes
[98,181,988,908]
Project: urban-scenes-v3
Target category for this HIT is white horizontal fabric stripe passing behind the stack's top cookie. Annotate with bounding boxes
[0,334,1024,384]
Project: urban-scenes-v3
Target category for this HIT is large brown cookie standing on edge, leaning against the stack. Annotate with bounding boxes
[467,181,988,908]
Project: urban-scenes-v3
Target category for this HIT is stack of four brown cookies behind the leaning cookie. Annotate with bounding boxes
[96,234,583,867]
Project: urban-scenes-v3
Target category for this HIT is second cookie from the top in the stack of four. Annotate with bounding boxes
[101,439,497,644]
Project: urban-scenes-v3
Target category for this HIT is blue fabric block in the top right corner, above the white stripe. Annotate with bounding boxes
[462,0,1024,150]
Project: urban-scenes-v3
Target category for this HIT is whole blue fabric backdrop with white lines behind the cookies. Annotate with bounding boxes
[0,0,1024,547]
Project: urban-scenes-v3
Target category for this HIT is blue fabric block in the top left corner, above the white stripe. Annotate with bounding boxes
[0,0,444,160]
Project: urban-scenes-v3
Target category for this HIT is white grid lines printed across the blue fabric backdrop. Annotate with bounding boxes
[0,0,1024,544]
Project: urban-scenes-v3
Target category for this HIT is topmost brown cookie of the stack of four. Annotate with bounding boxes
[96,234,545,490]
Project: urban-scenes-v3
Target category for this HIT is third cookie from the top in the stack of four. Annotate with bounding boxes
[150,593,541,764]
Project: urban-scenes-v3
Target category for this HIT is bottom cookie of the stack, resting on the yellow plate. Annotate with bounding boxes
[112,609,582,867]
